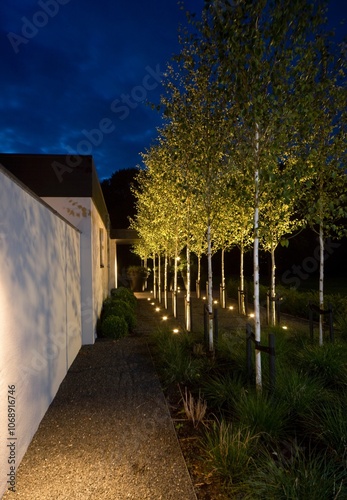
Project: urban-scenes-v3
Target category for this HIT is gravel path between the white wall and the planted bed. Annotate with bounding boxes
[3,299,196,500]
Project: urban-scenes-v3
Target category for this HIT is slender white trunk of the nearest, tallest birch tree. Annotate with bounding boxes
[253,124,262,391]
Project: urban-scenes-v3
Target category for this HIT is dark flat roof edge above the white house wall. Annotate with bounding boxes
[0,153,109,226]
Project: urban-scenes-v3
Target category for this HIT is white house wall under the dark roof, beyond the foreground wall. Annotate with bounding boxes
[43,197,114,344]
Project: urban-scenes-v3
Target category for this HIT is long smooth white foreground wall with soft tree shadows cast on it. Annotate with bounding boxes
[0,169,82,496]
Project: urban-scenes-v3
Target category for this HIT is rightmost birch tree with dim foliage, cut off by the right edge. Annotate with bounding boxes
[301,34,347,345]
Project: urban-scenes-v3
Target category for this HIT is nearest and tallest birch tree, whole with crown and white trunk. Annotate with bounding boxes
[198,0,332,389]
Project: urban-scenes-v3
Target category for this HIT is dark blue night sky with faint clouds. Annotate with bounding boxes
[0,0,347,179]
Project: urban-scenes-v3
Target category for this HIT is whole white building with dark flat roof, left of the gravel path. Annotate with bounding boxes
[0,155,116,497]
